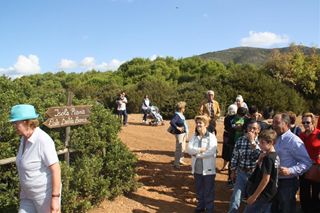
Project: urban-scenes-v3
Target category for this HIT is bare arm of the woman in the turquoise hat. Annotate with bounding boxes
[49,163,61,212]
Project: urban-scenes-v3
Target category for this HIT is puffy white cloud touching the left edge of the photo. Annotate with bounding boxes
[0,54,41,78]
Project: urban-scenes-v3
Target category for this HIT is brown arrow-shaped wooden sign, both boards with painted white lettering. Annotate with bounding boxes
[43,105,91,128]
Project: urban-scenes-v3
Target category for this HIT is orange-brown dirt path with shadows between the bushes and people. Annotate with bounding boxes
[89,114,231,213]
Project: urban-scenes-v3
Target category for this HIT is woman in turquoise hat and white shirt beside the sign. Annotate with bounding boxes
[10,104,61,213]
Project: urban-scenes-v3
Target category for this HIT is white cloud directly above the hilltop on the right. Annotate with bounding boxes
[240,31,290,47]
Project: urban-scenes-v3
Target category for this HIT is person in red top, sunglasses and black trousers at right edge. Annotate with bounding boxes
[299,113,320,212]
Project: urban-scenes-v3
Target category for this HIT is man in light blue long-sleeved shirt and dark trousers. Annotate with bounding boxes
[271,113,312,213]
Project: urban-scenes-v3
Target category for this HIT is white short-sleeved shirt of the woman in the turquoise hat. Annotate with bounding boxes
[16,127,59,199]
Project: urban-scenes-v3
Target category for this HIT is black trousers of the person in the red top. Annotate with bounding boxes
[300,176,320,213]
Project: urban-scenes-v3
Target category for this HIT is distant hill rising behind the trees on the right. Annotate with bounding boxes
[194,46,320,66]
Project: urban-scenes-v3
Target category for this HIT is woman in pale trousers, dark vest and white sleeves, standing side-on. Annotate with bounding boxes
[170,101,189,169]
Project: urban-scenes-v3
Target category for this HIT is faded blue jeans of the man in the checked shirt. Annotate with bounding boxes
[228,169,251,213]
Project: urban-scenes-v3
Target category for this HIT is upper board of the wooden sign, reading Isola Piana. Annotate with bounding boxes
[46,105,91,118]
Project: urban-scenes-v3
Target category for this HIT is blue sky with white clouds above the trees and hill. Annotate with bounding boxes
[0,0,320,78]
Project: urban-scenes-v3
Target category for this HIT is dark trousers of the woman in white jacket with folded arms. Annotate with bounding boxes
[194,174,216,213]
